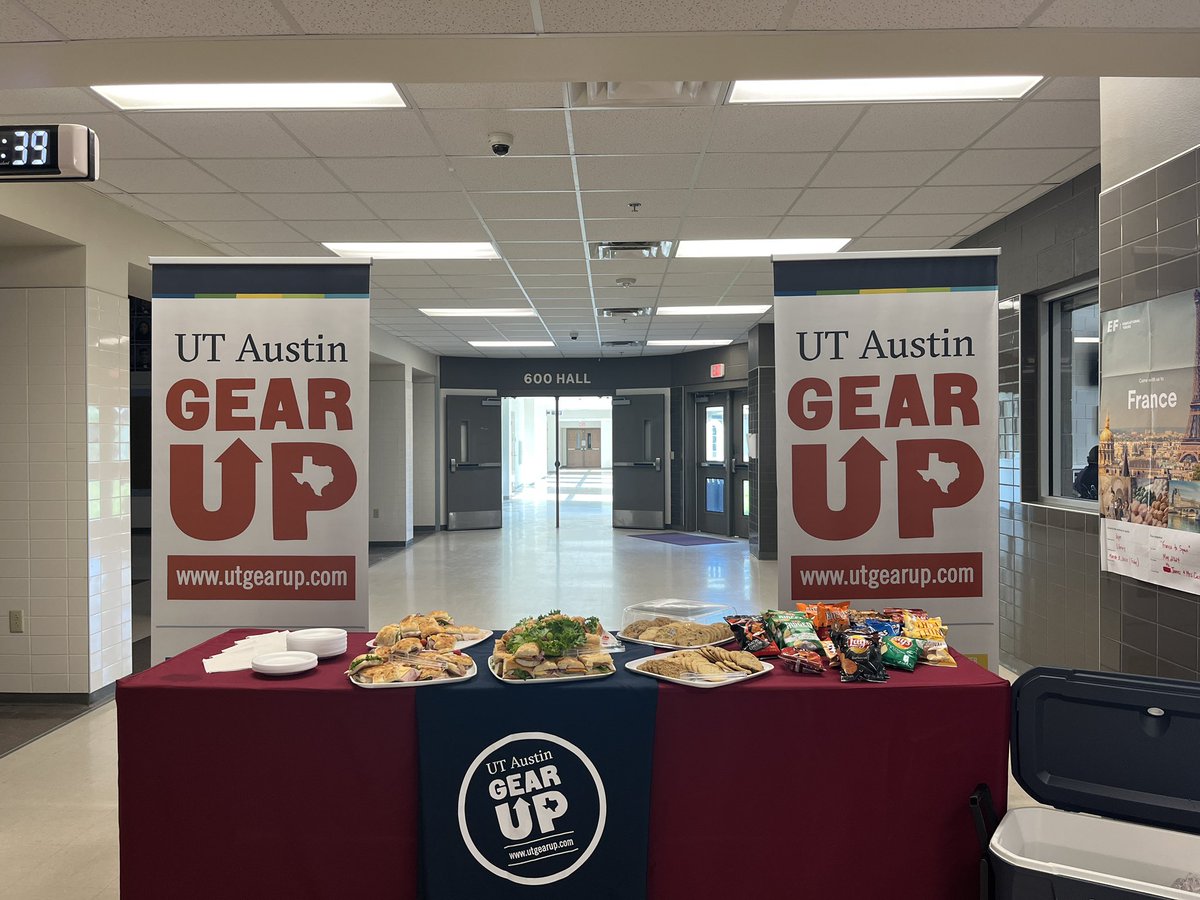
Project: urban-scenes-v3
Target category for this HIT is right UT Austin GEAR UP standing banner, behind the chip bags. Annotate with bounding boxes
[775,250,1000,667]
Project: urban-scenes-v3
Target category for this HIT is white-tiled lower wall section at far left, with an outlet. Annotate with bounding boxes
[0,287,132,694]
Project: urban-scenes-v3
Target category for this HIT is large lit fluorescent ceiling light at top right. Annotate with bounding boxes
[730,76,1042,103]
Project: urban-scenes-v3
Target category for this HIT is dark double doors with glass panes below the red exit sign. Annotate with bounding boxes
[694,389,750,538]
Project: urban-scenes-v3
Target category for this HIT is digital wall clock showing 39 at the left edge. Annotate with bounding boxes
[0,125,100,181]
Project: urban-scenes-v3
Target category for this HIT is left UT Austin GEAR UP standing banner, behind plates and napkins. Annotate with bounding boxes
[151,259,371,626]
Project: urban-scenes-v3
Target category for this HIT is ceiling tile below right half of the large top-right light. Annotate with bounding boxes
[840,101,1016,150]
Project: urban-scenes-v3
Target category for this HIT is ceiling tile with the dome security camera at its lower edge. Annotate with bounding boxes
[425,109,568,158]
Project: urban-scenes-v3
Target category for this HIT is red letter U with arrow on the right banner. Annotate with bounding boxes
[792,438,887,541]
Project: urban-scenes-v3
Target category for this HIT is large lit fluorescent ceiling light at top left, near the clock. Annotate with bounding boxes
[91,82,404,109]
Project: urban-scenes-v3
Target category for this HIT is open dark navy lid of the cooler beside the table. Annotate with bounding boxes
[1012,668,1200,833]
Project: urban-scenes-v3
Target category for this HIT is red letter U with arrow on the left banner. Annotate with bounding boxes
[170,438,262,541]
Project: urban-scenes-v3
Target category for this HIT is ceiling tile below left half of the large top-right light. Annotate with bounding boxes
[708,103,863,154]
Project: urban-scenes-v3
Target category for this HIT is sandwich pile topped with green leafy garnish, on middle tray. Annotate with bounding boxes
[491,610,616,682]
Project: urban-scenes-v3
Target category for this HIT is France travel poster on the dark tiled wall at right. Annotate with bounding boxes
[1097,290,1200,594]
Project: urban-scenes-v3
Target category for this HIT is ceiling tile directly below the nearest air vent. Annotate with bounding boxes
[571,107,713,155]
